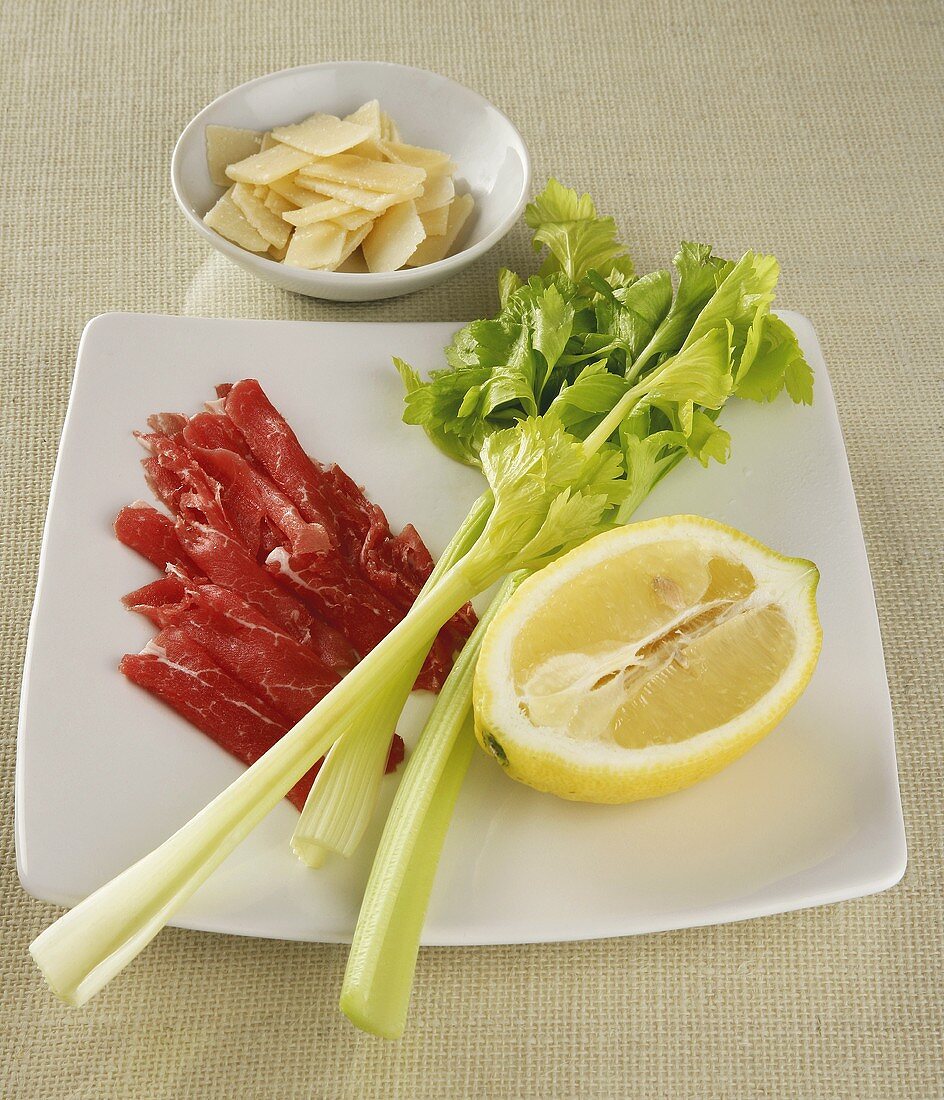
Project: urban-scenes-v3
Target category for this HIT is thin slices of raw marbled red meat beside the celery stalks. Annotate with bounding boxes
[116,380,475,807]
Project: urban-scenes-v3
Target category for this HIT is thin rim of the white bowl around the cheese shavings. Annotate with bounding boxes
[171,61,531,286]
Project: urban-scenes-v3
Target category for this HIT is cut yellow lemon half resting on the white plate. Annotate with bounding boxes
[474,516,822,802]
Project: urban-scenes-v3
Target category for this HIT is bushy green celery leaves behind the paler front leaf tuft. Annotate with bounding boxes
[389,179,813,486]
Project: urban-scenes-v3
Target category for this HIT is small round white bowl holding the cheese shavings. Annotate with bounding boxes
[171,62,531,301]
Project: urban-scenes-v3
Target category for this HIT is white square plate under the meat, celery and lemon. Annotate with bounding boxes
[17,314,905,944]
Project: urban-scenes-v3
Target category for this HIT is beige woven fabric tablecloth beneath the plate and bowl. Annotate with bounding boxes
[0,0,944,1100]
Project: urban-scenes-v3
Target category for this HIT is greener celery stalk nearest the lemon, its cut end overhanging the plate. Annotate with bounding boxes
[341,572,526,1038]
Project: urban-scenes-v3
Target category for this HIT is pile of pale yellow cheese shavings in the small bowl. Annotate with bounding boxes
[204,99,473,272]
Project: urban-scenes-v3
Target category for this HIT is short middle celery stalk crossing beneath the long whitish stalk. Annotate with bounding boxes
[292,491,493,868]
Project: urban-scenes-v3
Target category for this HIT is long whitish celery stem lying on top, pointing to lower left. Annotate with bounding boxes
[30,563,475,1004]
